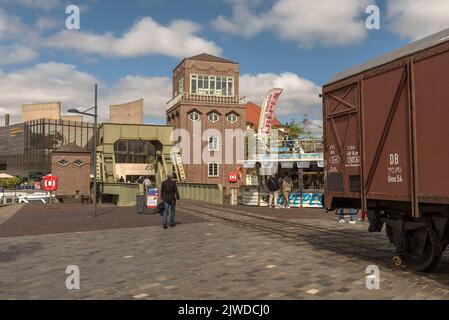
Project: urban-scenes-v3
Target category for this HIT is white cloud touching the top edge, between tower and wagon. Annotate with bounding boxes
[213,0,368,47]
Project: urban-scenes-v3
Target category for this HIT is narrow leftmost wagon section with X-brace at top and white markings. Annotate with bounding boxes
[323,83,361,208]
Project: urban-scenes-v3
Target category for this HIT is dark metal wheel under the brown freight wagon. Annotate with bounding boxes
[399,230,442,272]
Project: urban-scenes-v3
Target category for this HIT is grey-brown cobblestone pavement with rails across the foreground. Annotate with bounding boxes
[0,201,449,299]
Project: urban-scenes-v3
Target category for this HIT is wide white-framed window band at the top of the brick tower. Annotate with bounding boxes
[190,74,234,97]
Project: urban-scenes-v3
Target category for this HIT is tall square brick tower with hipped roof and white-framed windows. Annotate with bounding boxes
[167,54,246,194]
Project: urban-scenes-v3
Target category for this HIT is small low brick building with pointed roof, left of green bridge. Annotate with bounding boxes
[51,143,92,198]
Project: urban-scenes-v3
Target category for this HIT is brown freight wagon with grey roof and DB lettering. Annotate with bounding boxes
[323,29,449,271]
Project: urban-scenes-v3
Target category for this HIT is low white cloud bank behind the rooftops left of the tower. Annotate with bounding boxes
[0,62,171,122]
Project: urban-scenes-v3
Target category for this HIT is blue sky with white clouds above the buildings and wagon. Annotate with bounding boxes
[0,0,449,131]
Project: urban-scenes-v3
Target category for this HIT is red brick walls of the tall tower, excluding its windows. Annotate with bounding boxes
[167,54,246,194]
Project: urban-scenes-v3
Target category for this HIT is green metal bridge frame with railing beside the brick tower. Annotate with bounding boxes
[96,123,223,206]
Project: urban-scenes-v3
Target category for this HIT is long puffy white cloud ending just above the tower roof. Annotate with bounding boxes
[41,17,222,58]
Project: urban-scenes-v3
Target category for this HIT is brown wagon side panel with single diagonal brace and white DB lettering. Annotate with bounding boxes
[362,65,410,201]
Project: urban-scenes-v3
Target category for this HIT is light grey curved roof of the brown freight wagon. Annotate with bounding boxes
[325,28,449,86]
